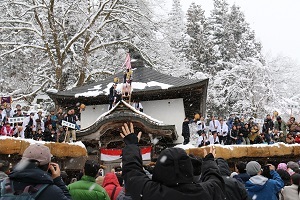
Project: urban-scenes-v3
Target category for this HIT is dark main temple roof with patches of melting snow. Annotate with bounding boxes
[48,67,203,97]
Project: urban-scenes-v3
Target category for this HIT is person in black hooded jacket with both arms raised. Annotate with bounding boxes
[120,123,225,200]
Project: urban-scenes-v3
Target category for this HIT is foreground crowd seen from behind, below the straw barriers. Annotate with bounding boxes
[0,123,300,200]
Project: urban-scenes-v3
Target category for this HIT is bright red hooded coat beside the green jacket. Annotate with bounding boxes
[102,172,123,200]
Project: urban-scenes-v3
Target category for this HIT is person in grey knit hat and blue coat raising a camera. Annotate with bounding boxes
[245,161,284,200]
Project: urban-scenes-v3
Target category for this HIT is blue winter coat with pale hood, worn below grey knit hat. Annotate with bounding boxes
[245,170,284,200]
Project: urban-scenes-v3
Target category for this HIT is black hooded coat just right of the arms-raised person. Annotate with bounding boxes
[216,158,248,200]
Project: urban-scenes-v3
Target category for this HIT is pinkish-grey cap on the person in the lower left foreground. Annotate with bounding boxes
[22,144,52,165]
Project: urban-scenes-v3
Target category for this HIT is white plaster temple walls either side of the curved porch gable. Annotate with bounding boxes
[81,98,185,143]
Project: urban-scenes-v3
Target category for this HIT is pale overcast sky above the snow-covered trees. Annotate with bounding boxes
[164,0,300,63]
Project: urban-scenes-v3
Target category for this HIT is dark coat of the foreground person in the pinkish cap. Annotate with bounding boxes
[2,161,71,200]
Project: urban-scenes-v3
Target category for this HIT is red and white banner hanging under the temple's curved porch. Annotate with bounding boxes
[100,147,151,161]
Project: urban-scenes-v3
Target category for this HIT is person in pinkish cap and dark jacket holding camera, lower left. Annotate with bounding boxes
[1,144,71,200]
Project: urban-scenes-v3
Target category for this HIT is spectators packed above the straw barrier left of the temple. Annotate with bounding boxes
[0,103,80,142]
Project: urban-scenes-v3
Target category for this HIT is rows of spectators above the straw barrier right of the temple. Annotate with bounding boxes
[182,113,300,147]
